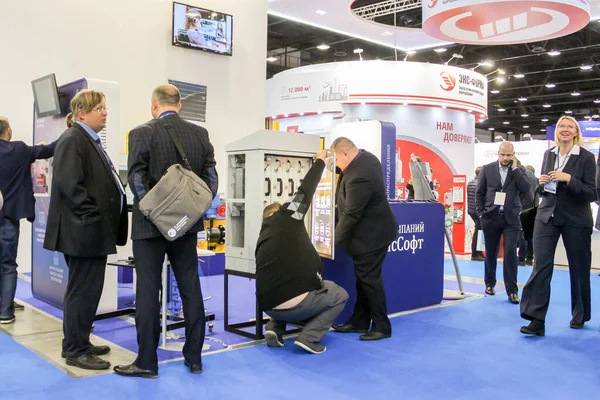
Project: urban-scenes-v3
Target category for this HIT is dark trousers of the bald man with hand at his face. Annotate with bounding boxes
[481,213,521,294]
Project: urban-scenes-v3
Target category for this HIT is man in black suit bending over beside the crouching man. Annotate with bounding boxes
[331,137,398,340]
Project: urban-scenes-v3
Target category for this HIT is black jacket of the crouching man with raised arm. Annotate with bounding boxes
[255,159,325,311]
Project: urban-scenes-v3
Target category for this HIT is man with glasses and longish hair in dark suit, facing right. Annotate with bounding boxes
[44,90,127,370]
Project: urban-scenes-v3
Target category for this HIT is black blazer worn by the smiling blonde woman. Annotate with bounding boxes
[535,147,597,228]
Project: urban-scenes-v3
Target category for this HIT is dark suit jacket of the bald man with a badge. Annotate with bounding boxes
[475,161,531,225]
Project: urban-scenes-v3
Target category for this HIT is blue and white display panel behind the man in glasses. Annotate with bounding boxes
[31,79,87,309]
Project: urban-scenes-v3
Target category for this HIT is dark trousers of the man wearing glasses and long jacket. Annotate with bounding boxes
[62,255,106,358]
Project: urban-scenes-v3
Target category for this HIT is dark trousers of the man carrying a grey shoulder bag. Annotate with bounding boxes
[133,232,205,371]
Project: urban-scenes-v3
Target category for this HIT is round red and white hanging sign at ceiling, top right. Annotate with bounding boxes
[423,0,590,45]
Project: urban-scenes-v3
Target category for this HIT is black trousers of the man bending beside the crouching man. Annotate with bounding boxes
[348,246,392,334]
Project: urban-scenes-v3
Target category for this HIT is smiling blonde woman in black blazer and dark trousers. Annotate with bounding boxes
[521,117,596,336]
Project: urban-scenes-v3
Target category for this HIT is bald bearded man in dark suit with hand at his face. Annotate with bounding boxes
[476,142,531,304]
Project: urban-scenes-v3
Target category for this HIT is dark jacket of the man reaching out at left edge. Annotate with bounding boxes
[0,139,56,222]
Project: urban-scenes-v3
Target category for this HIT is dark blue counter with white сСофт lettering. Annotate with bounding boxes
[323,202,444,324]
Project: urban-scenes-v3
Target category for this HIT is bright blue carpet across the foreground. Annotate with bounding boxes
[0,262,600,400]
